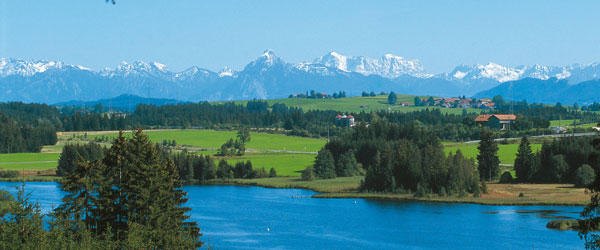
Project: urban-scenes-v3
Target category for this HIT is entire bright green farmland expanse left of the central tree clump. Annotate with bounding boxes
[7,130,326,176]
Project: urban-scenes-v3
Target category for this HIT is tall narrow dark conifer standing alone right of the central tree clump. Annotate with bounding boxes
[477,127,500,181]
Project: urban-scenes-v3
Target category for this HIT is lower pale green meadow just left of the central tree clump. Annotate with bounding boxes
[227,153,316,176]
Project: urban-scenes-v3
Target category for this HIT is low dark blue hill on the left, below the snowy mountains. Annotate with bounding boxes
[54,94,187,112]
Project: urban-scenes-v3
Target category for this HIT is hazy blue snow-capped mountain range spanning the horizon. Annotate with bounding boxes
[0,50,600,104]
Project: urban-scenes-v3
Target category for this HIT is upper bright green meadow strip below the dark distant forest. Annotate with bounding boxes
[79,129,326,152]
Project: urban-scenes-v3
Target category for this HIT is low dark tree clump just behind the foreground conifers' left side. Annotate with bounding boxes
[56,142,105,176]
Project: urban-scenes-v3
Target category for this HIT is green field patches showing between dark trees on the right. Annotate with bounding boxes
[444,143,542,165]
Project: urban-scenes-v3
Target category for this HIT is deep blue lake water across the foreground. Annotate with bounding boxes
[0,182,583,249]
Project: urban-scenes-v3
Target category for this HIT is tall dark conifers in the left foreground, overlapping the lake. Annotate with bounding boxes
[53,130,201,249]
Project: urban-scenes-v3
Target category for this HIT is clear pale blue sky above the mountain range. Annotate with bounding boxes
[0,0,600,73]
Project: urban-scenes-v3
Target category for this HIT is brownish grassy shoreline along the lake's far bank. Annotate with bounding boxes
[0,176,590,206]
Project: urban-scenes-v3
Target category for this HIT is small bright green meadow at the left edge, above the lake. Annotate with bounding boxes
[0,153,60,170]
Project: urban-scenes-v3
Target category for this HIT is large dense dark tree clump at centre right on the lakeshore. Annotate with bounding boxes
[312,121,480,195]
